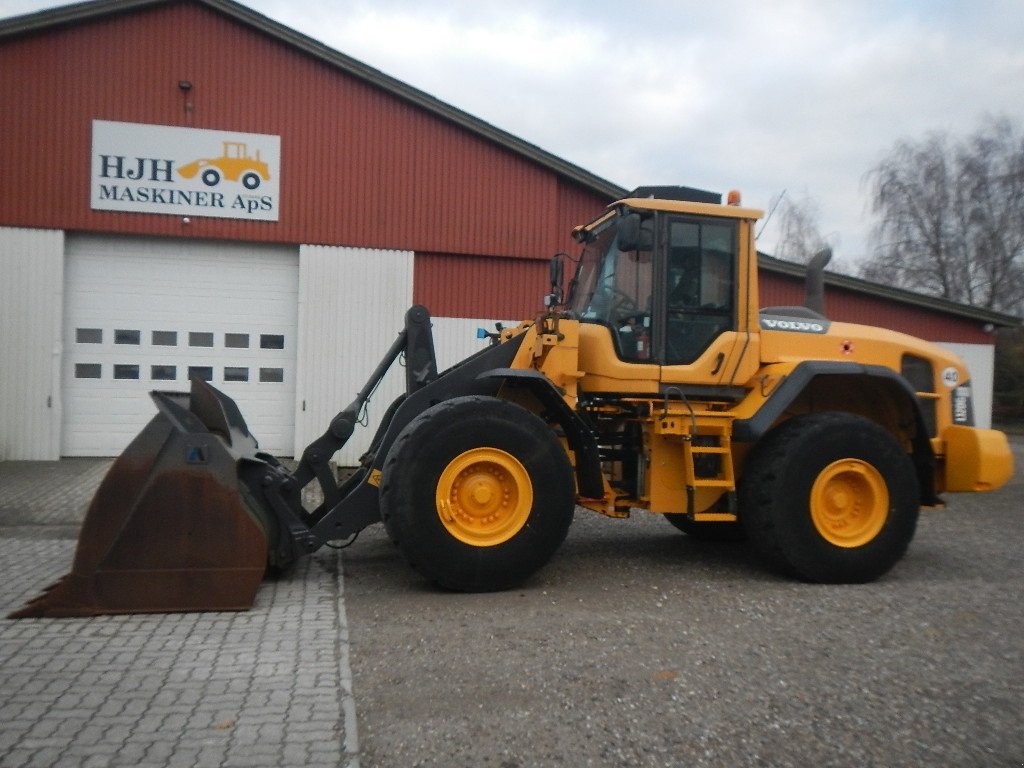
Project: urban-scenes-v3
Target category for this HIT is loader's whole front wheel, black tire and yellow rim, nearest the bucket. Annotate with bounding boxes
[381,396,575,592]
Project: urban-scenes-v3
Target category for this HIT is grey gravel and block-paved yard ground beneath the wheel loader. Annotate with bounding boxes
[0,437,1024,768]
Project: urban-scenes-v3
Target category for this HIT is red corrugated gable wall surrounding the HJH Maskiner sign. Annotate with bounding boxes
[0,2,608,259]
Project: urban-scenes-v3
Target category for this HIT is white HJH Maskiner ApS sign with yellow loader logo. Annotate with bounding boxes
[90,120,281,221]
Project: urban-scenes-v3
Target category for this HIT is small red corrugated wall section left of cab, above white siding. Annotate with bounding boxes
[413,253,550,319]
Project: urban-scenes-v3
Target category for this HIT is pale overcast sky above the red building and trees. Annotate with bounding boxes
[6,0,1024,262]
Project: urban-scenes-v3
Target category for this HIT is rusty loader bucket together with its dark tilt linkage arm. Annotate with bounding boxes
[10,306,437,618]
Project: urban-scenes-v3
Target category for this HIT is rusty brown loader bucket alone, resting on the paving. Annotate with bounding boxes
[10,380,273,618]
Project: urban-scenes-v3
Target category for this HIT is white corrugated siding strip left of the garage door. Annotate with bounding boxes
[0,228,63,461]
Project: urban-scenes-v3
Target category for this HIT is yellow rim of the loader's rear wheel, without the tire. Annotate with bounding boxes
[811,459,889,548]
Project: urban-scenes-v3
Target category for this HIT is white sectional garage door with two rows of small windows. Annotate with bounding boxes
[61,236,299,456]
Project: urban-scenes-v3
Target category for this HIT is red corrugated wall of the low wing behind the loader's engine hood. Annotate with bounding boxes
[759,270,992,344]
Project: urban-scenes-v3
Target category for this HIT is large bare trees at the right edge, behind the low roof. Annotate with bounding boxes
[862,118,1024,311]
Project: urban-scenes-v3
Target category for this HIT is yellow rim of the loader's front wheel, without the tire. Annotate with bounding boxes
[436,447,534,547]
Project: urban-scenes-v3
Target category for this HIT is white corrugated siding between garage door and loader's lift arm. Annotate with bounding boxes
[295,246,413,466]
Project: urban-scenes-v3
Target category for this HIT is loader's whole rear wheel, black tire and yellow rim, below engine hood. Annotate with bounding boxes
[739,413,920,584]
